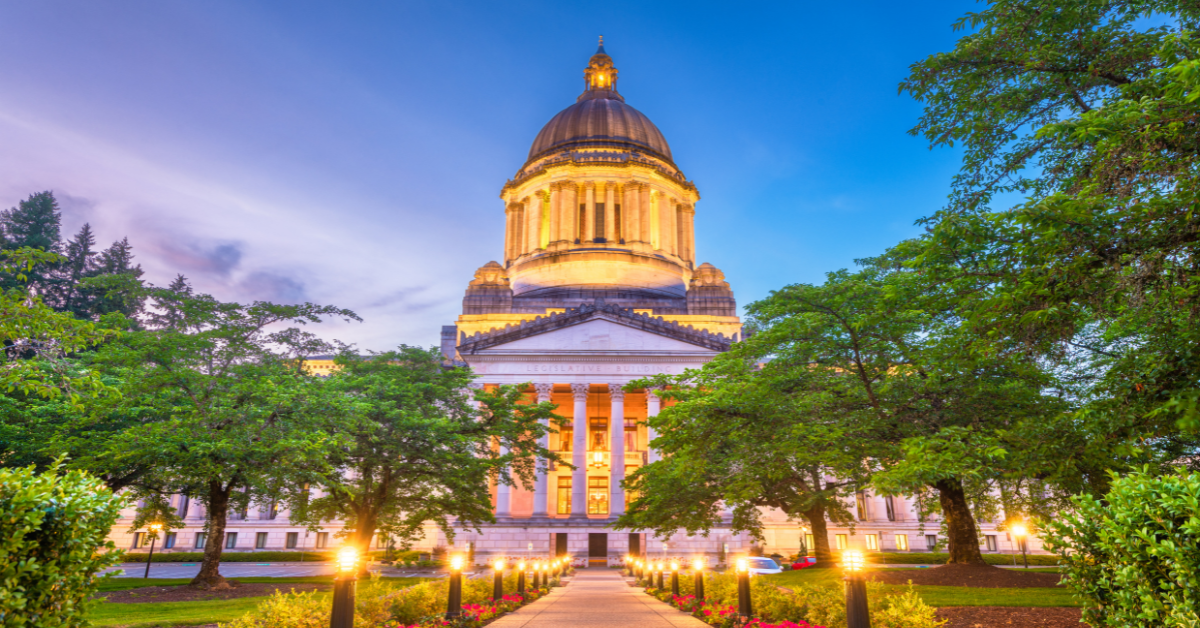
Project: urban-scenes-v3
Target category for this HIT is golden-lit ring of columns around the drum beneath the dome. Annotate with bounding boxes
[504,181,696,262]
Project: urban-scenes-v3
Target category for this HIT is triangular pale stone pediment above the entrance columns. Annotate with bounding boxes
[481,318,704,353]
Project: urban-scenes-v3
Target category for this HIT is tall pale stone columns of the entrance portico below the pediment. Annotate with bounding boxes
[496,383,662,519]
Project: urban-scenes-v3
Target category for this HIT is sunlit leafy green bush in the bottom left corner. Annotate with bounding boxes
[0,467,122,628]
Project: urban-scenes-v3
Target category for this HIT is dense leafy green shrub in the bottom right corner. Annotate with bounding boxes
[1046,473,1200,628]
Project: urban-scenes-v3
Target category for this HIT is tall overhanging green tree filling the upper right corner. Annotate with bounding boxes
[900,0,1200,482]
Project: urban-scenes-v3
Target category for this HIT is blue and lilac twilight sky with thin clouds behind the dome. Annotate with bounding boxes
[0,0,982,351]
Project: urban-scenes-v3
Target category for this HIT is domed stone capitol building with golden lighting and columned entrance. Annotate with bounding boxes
[114,41,1037,563]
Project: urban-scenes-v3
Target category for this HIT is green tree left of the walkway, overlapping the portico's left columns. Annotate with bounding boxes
[288,346,569,559]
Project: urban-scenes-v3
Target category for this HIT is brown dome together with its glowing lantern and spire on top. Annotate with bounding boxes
[529,37,673,163]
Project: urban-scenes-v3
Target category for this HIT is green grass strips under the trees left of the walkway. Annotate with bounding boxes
[88,576,426,628]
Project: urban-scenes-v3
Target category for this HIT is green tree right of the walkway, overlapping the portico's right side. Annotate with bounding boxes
[617,353,871,567]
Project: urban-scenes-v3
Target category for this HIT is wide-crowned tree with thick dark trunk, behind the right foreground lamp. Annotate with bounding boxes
[746,265,1063,564]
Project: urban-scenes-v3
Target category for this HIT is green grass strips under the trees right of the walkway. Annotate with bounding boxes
[761,569,1081,606]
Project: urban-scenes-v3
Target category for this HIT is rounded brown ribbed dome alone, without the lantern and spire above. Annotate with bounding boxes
[529,97,672,161]
